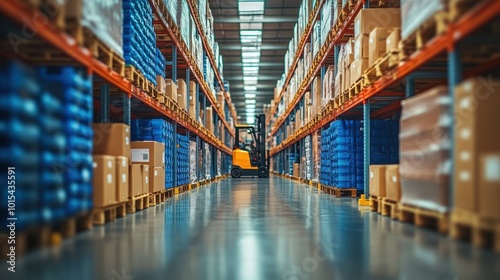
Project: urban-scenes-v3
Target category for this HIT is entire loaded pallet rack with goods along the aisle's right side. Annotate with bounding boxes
[268,0,500,250]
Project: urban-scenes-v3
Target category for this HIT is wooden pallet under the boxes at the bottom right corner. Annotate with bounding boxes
[450,209,500,252]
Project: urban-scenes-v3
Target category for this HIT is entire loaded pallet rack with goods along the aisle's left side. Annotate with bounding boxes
[0,0,236,254]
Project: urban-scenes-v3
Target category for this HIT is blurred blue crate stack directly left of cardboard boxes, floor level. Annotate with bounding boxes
[38,66,93,215]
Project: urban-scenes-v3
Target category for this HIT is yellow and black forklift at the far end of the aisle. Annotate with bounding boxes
[231,114,269,178]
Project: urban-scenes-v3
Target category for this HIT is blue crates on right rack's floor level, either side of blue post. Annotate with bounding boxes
[320,120,399,194]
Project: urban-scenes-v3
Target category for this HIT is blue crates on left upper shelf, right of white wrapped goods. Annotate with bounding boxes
[122,0,156,85]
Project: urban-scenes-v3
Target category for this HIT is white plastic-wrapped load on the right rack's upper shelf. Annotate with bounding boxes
[401,0,448,40]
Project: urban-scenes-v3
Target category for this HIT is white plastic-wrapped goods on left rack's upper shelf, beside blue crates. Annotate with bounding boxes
[66,0,123,57]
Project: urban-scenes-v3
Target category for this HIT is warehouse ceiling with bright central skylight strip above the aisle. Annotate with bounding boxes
[209,0,301,123]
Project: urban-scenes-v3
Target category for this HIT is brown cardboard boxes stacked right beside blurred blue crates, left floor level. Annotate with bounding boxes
[92,123,130,207]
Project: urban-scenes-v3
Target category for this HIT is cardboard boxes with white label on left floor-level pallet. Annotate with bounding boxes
[131,141,165,196]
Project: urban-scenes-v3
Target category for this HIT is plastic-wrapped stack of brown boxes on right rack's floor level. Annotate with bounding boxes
[399,86,452,212]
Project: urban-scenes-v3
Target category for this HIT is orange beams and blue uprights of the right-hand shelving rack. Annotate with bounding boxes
[268,0,500,201]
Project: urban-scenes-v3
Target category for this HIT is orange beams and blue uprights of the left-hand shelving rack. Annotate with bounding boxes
[0,0,235,186]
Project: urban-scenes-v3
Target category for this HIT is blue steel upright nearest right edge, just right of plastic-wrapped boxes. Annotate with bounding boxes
[448,43,463,209]
